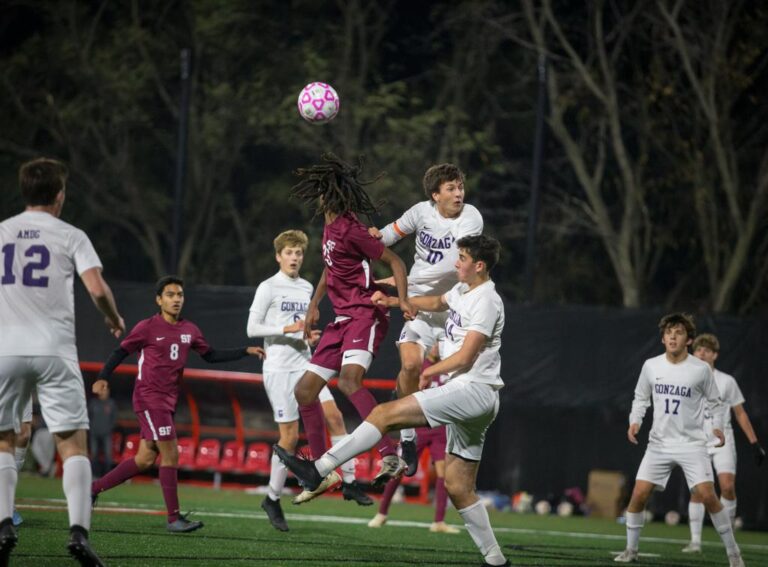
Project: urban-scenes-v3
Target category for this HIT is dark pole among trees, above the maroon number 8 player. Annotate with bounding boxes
[168,48,192,274]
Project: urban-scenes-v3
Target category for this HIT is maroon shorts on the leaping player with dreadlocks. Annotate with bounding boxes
[309,312,389,372]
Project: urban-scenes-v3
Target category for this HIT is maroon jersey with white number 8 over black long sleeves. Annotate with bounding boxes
[120,315,211,412]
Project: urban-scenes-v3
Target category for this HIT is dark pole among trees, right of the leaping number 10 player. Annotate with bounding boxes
[524,53,547,303]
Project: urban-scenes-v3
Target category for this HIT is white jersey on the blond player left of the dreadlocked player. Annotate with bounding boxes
[248,272,312,372]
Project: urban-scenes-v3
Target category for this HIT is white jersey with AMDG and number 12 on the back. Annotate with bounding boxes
[0,211,101,361]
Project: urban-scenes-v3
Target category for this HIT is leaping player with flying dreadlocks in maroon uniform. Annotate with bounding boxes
[291,154,416,504]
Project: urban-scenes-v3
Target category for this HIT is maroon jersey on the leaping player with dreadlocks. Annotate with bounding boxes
[323,212,386,318]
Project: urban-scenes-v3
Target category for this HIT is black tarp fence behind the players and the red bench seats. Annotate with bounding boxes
[76,282,768,529]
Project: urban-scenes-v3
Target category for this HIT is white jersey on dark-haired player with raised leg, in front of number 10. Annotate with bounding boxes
[444,280,504,388]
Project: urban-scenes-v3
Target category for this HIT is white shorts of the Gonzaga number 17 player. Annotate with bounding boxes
[635,447,715,490]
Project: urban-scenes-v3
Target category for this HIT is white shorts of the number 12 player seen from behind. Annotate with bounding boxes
[0,356,88,433]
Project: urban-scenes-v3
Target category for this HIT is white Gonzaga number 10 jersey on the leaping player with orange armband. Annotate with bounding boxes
[381,201,483,296]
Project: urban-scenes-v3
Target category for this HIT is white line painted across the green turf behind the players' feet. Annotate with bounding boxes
[17,498,768,551]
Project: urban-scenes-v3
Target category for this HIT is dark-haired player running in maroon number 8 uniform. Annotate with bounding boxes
[91,276,264,532]
